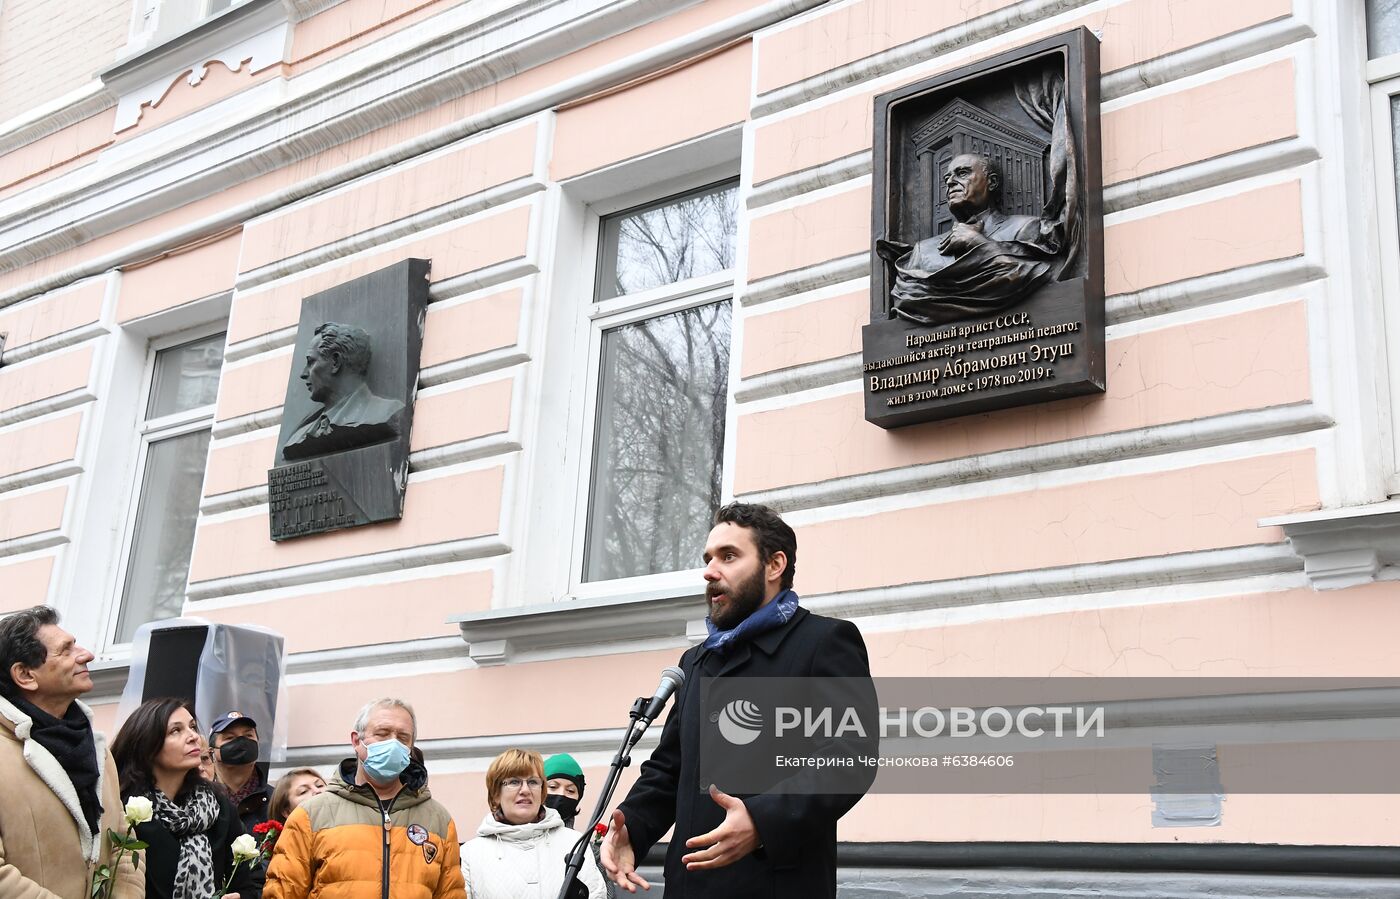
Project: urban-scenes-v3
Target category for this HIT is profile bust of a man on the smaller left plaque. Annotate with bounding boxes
[281,322,403,461]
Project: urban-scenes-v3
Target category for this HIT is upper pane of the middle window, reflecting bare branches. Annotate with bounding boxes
[598,181,739,300]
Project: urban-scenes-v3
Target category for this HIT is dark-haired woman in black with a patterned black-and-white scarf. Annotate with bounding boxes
[112,699,251,899]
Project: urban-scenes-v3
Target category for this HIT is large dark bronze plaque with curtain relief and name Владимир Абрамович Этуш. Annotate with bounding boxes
[862,28,1105,427]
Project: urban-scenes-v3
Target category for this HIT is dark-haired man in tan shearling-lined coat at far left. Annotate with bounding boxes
[0,606,146,899]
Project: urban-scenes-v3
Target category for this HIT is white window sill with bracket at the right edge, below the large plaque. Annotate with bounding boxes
[1259,499,1400,590]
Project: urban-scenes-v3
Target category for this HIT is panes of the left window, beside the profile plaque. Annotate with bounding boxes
[111,333,224,644]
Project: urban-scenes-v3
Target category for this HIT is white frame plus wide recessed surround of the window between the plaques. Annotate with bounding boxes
[512,134,745,608]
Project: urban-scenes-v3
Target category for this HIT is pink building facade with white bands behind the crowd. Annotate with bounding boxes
[0,0,1400,896]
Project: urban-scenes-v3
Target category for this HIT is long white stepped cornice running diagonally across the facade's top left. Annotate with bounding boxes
[0,0,822,307]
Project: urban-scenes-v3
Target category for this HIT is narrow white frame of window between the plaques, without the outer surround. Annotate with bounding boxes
[568,165,739,599]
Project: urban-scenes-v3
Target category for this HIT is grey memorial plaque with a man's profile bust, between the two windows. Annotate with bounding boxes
[267,259,428,541]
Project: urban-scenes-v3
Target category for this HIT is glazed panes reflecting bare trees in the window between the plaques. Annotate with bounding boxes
[580,181,738,583]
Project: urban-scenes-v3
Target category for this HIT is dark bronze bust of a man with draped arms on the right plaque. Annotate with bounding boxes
[875,153,1060,325]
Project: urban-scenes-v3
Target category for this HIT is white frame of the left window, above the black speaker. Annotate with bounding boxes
[98,321,228,655]
